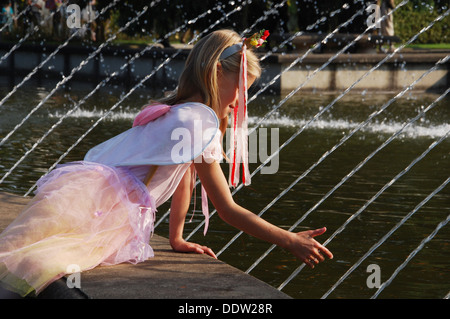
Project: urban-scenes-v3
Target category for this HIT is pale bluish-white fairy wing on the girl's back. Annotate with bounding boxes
[84,103,219,166]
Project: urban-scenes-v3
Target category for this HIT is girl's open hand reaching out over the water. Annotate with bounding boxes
[290,227,333,268]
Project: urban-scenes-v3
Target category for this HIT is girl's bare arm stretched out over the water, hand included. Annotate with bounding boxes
[195,160,333,268]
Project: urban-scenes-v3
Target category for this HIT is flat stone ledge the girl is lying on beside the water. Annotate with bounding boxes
[0,193,289,299]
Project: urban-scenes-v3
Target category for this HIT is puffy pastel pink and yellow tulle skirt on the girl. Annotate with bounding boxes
[0,162,156,296]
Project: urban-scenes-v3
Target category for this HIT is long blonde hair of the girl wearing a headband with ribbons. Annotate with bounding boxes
[159,30,261,135]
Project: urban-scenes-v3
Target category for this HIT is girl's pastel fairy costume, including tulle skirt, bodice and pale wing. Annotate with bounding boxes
[0,103,222,296]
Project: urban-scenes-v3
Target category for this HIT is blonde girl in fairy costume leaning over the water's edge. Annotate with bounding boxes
[0,30,332,296]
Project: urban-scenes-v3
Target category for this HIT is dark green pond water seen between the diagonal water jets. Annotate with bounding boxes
[0,80,450,298]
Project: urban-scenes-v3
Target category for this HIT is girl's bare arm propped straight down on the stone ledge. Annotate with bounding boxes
[169,166,217,258]
